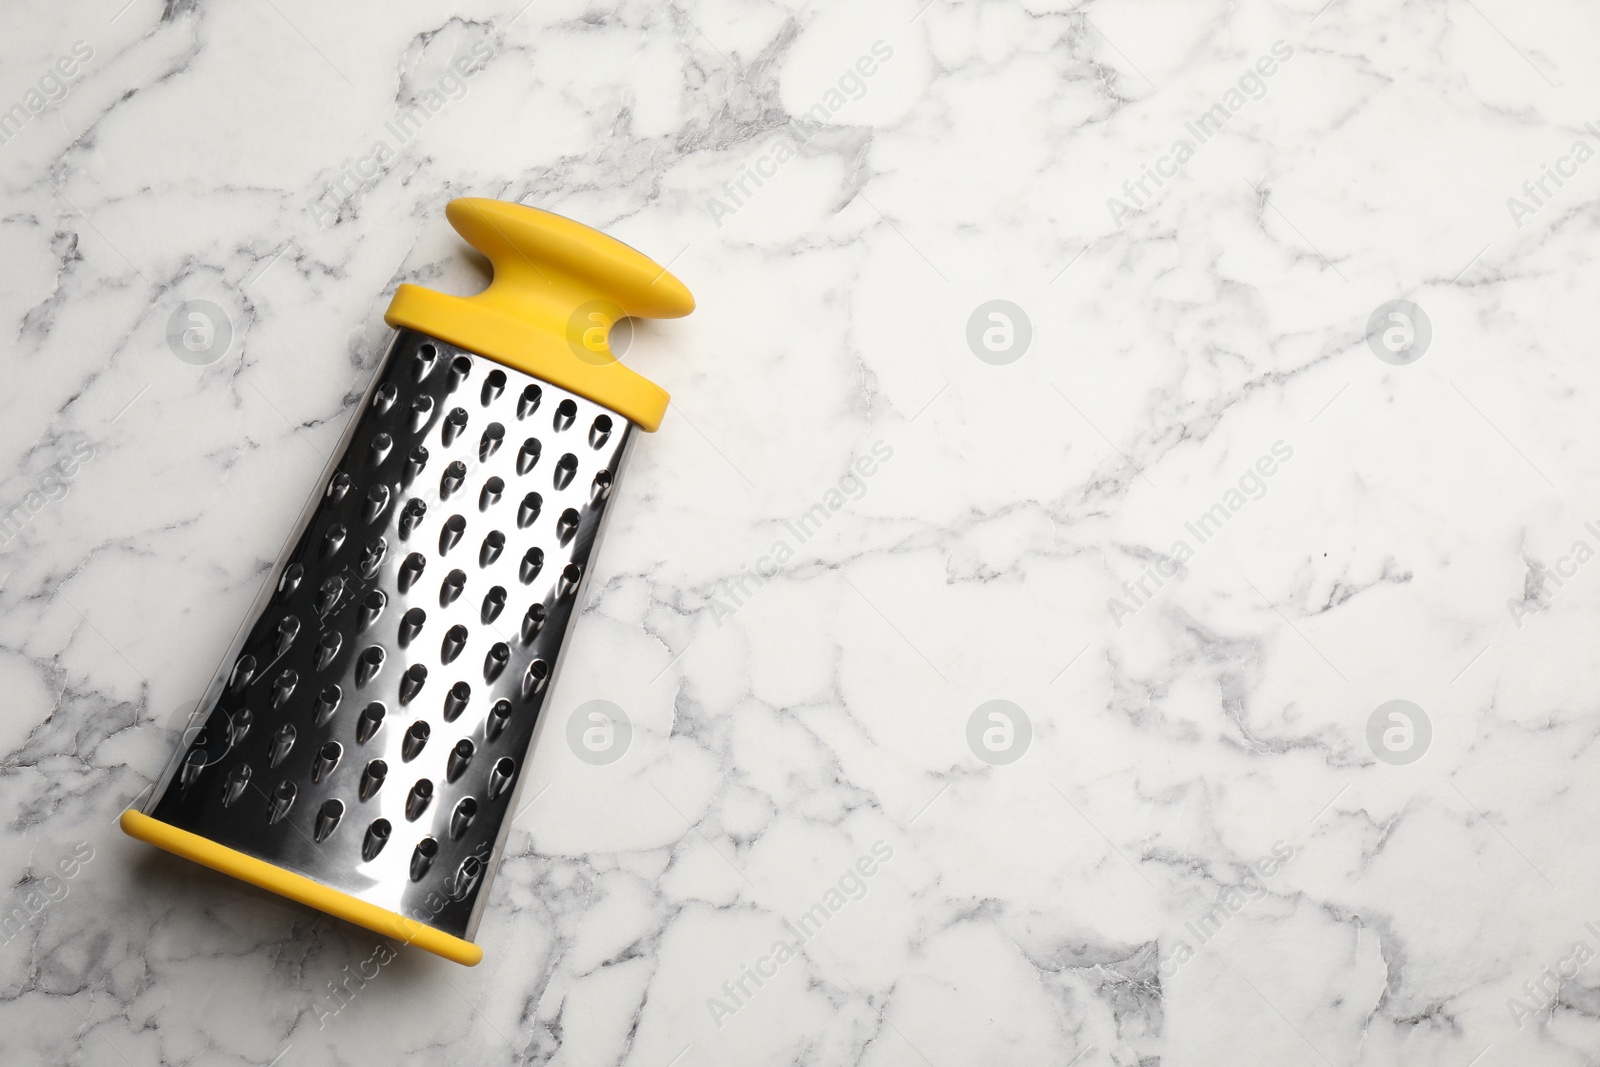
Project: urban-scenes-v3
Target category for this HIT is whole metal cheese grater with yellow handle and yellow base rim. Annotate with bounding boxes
[122,198,694,966]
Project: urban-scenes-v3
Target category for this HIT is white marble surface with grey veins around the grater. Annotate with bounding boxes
[0,0,1600,1067]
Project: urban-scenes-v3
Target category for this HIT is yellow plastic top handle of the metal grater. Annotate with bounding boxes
[384,197,694,430]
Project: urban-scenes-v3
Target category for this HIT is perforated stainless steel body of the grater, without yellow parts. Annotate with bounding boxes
[146,330,635,941]
